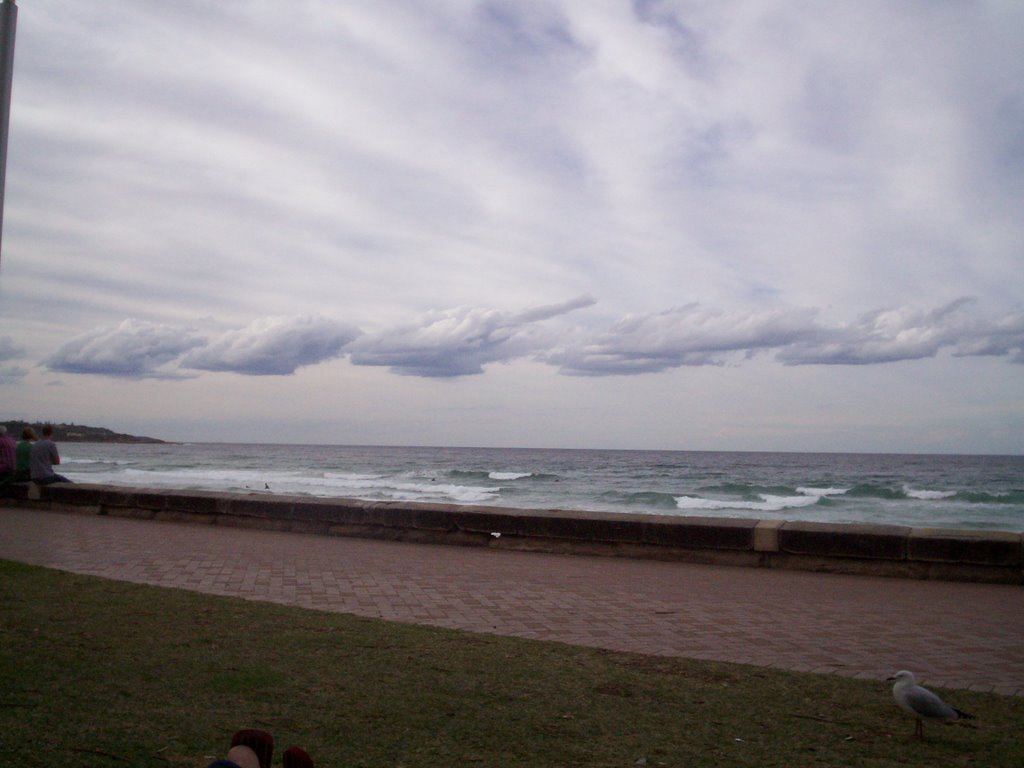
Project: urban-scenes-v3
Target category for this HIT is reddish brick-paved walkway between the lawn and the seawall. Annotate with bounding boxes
[0,508,1024,695]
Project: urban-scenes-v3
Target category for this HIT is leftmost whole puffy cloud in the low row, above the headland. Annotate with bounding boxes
[43,318,205,379]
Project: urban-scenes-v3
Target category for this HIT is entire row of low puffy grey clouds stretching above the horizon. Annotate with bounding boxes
[32,296,1024,382]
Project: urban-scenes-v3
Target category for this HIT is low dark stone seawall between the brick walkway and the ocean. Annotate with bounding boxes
[0,483,1024,584]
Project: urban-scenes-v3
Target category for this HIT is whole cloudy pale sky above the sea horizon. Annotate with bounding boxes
[0,0,1024,454]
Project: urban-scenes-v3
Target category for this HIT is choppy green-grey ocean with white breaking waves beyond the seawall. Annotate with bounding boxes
[59,443,1024,531]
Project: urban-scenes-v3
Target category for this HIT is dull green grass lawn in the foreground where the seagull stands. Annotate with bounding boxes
[0,561,1024,768]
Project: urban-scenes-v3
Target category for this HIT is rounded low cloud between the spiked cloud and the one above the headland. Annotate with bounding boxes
[181,316,362,376]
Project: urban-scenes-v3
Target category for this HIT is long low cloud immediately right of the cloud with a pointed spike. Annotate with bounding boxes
[548,304,818,376]
